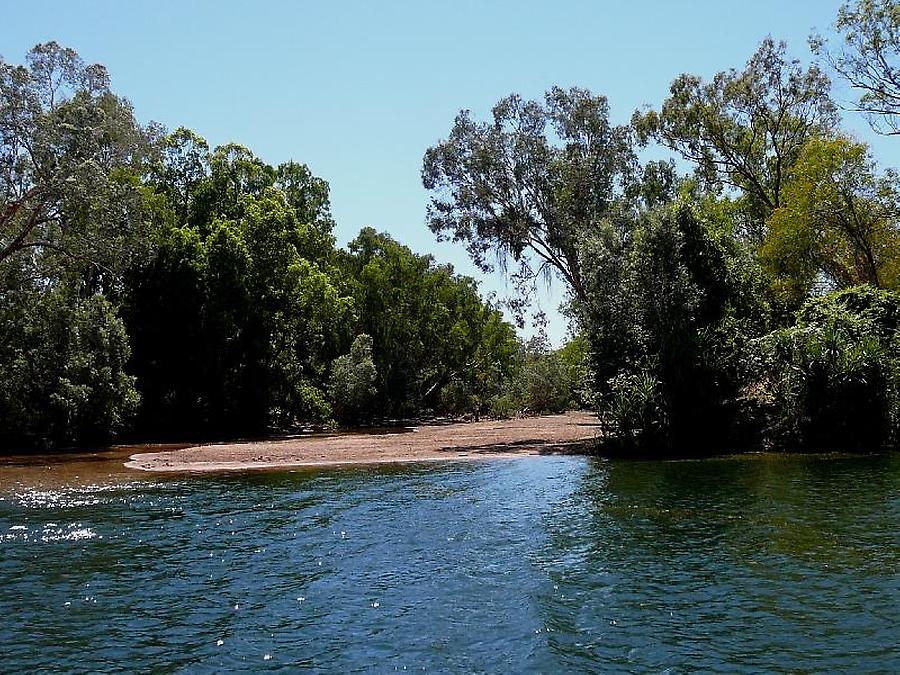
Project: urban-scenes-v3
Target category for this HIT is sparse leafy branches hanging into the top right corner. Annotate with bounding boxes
[810,0,900,136]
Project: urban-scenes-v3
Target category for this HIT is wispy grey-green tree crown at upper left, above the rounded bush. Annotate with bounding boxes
[0,42,150,291]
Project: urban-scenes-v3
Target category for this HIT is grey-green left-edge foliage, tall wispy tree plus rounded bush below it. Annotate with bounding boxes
[0,42,153,449]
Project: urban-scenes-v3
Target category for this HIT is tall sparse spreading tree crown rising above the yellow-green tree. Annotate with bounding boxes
[632,38,837,241]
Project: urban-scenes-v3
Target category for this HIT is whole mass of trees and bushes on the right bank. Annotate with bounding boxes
[422,0,900,454]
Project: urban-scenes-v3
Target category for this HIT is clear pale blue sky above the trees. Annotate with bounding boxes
[0,0,900,341]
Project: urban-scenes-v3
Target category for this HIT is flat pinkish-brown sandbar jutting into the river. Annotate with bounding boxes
[125,412,597,472]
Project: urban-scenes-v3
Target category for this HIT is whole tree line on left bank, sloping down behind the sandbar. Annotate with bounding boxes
[0,43,580,449]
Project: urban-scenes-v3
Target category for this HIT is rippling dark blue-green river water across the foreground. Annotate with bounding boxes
[0,455,900,673]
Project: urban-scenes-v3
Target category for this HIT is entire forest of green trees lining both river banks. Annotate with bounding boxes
[0,0,900,456]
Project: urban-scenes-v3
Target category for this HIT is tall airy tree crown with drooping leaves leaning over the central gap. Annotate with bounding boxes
[422,87,637,299]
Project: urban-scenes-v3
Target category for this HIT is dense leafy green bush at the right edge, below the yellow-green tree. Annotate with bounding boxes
[754,286,900,451]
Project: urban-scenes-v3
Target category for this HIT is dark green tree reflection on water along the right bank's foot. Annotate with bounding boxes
[583,454,900,572]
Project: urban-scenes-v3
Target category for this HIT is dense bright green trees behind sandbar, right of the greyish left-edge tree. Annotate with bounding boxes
[125,139,515,437]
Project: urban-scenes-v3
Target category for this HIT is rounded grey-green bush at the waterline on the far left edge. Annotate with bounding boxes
[0,289,138,449]
